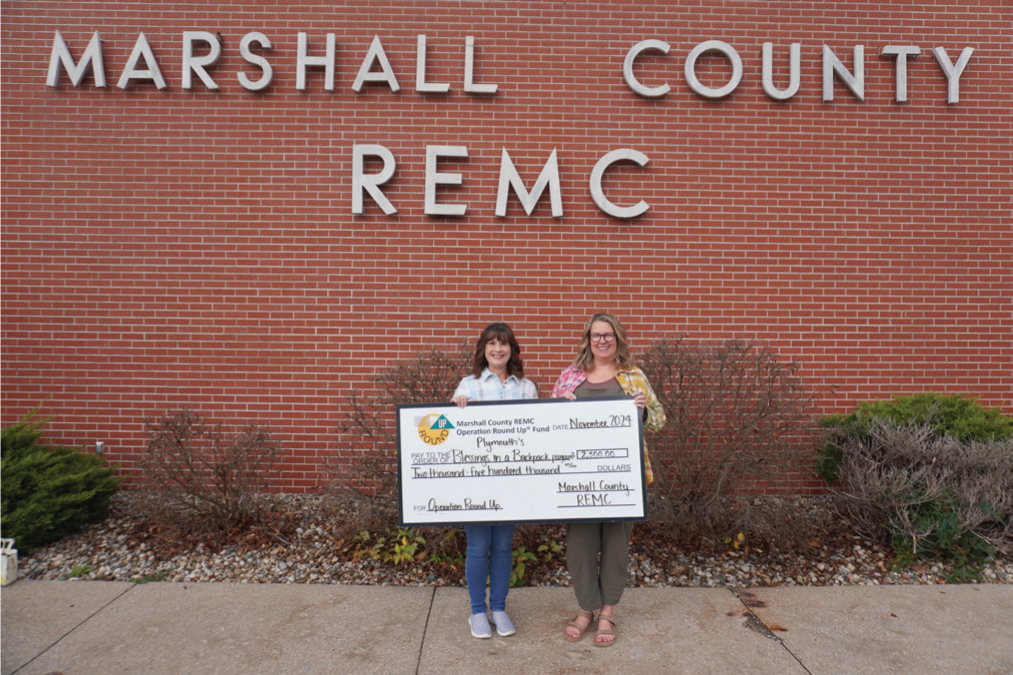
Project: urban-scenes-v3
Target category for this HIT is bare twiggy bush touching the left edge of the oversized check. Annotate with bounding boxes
[328,342,474,533]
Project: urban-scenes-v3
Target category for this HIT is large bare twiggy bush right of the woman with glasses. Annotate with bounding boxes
[638,336,819,546]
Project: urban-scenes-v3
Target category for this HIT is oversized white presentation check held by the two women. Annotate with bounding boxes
[397,397,647,526]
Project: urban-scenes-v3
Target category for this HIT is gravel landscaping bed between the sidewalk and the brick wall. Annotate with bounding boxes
[19,494,1013,587]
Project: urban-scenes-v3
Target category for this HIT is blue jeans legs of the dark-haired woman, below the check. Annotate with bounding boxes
[464,524,514,614]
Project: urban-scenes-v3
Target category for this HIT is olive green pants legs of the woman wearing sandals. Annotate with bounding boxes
[566,522,633,612]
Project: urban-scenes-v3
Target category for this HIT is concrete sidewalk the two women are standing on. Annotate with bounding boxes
[0,580,1013,675]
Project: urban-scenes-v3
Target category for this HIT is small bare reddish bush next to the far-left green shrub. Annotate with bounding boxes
[140,409,281,534]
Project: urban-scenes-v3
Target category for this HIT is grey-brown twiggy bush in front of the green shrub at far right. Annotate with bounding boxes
[831,420,1013,567]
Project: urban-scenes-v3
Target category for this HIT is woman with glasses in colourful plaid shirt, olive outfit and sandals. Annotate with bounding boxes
[552,313,666,647]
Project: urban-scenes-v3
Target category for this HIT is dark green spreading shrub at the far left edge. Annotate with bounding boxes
[0,407,123,553]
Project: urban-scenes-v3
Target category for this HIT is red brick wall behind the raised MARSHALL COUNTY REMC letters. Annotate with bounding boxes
[0,0,1013,491]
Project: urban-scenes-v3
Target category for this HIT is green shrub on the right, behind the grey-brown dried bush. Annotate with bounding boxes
[816,393,1013,482]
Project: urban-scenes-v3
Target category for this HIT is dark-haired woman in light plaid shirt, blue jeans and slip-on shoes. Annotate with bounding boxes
[452,322,538,638]
